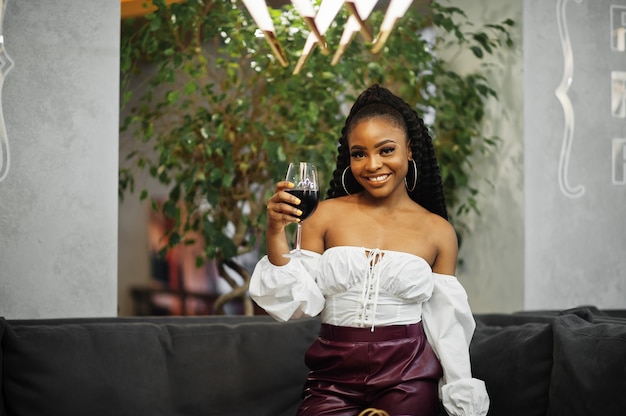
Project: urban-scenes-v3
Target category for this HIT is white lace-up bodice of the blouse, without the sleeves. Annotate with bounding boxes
[316,246,433,329]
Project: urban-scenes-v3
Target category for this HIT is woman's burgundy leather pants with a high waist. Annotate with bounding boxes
[298,323,443,416]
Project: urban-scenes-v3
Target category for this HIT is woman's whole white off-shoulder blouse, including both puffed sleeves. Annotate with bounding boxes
[250,246,489,416]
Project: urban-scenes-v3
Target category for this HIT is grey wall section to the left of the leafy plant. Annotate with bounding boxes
[0,0,120,319]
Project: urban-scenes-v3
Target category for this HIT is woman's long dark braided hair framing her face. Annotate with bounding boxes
[327,84,448,219]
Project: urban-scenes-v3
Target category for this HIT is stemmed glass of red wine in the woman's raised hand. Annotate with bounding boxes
[283,162,320,258]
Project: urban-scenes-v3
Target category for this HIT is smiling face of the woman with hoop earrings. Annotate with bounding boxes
[348,117,412,198]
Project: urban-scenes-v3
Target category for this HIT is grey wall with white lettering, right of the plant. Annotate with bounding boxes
[524,0,626,309]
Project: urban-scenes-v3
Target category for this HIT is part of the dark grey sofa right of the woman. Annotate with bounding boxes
[470,307,626,416]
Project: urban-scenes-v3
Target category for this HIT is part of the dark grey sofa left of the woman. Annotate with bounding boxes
[2,317,319,416]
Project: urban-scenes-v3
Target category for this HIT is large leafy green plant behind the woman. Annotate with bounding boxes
[120,0,513,314]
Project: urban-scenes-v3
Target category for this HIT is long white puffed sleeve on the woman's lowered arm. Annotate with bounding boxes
[423,273,489,416]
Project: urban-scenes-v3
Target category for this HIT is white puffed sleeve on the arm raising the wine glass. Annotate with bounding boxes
[249,250,324,321]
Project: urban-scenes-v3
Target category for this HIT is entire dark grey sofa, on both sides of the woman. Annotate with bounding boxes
[0,307,626,416]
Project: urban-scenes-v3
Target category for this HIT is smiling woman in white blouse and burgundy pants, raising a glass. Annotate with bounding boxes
[250,85,489,416]
